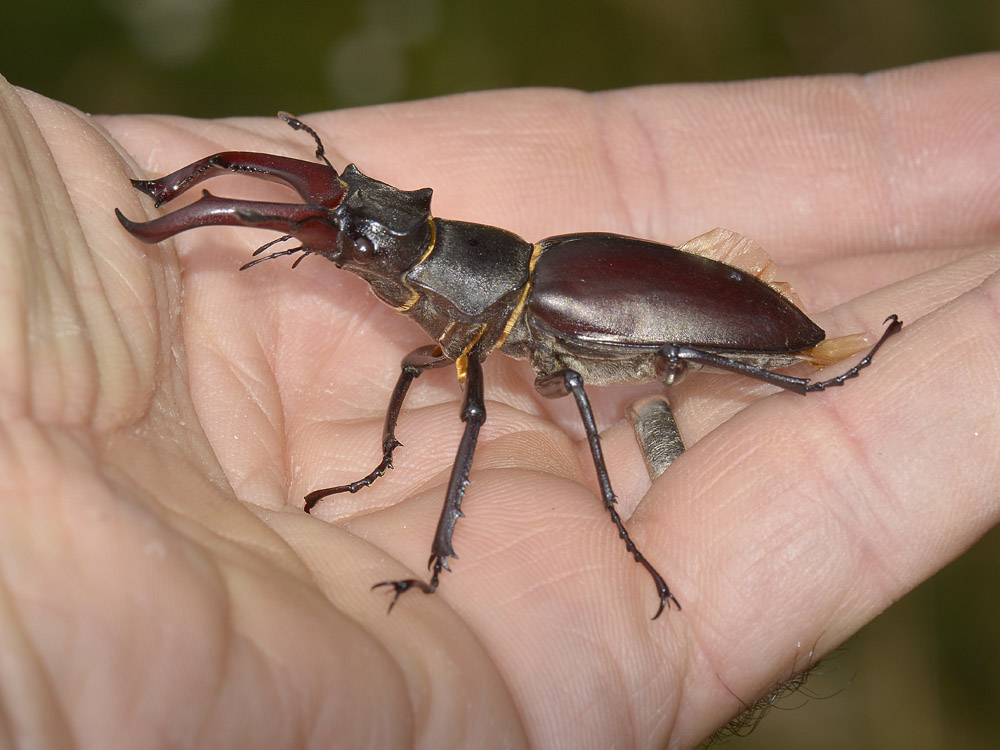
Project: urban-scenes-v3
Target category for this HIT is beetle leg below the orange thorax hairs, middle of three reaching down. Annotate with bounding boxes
[372,350,486,611]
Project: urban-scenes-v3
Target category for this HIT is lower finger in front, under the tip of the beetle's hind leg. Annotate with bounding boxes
[637,254,1000,697]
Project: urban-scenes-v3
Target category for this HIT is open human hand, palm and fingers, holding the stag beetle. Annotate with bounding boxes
[0,55,1000,748]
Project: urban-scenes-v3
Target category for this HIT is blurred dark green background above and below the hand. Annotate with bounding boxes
[0,0,1000,749]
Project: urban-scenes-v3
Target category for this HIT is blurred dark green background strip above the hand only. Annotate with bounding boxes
[0,0,1000,117]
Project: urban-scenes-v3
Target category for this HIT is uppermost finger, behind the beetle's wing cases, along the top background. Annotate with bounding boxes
[610,55,1000,257]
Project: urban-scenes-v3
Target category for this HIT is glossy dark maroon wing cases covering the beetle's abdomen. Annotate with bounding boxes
[526,233,825,352]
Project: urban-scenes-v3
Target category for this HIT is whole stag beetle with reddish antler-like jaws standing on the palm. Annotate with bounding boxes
[115,113,902,620]
